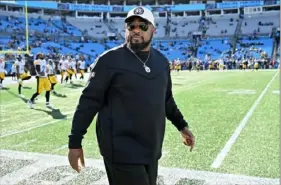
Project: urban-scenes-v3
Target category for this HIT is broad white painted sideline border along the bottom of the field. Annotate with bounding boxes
[0,150,279,185]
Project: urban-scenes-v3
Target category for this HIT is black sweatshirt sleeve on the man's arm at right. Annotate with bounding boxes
[166,70,188,131]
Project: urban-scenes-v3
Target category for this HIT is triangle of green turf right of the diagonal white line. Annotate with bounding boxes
[218,72,280,178]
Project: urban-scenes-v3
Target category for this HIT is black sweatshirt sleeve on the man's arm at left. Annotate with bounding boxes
[68,56,111,149]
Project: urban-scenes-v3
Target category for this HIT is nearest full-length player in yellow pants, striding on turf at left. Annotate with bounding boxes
[27,53,55,110]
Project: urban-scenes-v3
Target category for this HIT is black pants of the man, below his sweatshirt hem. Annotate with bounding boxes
[104,160,158,185]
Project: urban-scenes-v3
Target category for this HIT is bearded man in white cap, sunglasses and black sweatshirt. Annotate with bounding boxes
[68,7,194,185]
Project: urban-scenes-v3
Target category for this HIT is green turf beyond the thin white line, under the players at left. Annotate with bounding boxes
[0,83,82,135]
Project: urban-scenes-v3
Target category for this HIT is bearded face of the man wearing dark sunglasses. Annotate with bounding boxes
[126,17,155,52]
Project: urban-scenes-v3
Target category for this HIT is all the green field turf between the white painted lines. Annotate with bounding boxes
[0,71,279,178]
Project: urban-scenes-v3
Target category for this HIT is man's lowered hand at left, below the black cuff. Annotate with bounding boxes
[68,148,85,173]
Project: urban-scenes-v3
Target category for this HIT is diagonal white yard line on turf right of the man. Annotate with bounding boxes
[211,72,278,168]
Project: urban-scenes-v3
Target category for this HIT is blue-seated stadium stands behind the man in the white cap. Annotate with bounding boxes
[0,1,280,75]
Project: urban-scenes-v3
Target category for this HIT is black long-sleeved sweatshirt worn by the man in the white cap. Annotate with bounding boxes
[69,44,188,164]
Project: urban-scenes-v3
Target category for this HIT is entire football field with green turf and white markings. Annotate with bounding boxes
[0,70,280,185]
